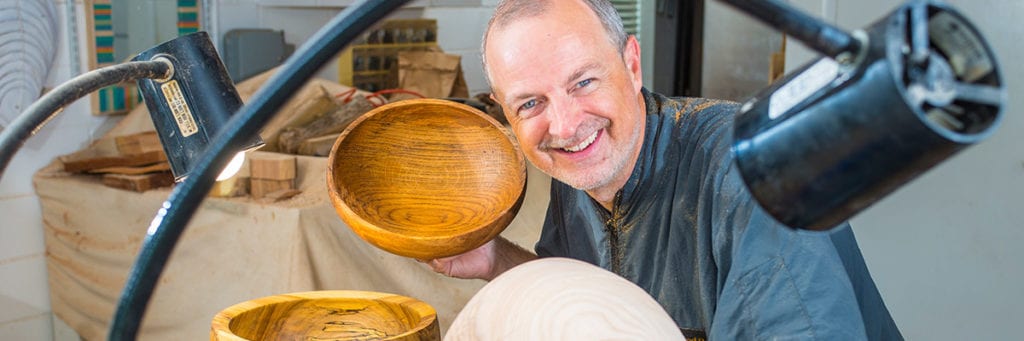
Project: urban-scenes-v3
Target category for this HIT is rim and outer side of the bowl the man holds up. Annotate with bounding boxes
[326,98,527,259]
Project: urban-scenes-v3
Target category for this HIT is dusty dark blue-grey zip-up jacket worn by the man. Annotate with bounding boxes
[536,90,902,340]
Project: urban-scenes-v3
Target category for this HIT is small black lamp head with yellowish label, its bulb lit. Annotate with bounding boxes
[132,32,263,181]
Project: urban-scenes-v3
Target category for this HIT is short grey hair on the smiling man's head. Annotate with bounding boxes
[480,0,627,84]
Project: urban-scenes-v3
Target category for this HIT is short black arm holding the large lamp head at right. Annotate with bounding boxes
[721,0,860,58]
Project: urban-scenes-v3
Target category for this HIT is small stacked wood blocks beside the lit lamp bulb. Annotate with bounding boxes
[249,153,300,202]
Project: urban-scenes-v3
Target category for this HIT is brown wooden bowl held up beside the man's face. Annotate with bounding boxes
[327,99,526,259]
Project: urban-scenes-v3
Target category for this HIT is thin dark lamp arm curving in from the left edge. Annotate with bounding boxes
[0,61,171,177]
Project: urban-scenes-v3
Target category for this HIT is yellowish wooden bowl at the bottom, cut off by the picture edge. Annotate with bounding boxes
[210,291,440,341]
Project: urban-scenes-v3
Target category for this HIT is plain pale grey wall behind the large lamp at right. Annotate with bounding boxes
[786,0,1024,340]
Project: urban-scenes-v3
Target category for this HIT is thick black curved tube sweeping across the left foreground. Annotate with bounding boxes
[109,0,409,340]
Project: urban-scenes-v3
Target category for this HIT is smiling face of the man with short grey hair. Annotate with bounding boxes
[486,1,644,195]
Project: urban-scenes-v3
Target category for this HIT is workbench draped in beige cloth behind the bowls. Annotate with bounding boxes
[34,151,550,340]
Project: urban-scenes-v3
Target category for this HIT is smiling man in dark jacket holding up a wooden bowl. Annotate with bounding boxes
[428,0,902,340]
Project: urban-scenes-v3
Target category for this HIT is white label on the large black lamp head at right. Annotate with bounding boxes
[768,58,839,120]
